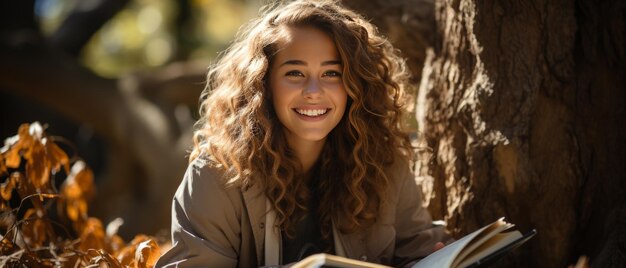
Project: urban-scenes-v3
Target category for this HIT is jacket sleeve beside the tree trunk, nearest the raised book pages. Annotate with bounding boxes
[393,160,450,267]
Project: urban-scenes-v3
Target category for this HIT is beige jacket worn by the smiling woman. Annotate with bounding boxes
[156,160,445,267]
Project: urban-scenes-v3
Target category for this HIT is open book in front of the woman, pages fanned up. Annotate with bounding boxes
[292,218,536,268]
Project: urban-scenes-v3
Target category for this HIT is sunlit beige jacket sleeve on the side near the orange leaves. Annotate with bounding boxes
[156,160,243,267]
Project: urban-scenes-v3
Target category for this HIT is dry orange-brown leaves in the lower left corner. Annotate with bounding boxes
[0,122,160,267]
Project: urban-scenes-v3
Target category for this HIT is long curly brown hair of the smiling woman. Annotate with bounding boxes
[191,0,413,238]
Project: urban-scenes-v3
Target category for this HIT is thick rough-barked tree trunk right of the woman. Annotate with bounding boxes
[416,0,626,267]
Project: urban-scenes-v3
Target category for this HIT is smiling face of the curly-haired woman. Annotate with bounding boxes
[269,26,348,143]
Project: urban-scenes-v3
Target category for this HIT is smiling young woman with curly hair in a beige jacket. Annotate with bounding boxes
[157,1,443,267]
